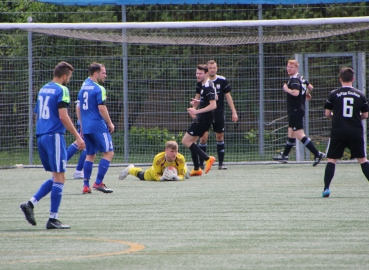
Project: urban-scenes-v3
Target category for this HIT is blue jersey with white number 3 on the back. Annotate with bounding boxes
[78,78,109,134]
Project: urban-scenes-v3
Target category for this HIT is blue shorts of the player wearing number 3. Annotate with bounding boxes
[83,132,114,156]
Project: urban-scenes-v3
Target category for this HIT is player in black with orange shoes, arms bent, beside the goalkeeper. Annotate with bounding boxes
[182,65,217,175]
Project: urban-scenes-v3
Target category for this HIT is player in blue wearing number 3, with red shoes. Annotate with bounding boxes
[77,62,114,194]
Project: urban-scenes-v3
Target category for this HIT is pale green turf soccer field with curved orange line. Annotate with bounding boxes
[0,164,369,269]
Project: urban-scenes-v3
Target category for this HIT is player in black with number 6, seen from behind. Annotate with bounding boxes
[322,67,369,197]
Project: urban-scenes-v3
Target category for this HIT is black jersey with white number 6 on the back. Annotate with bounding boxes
[324,87,369,139]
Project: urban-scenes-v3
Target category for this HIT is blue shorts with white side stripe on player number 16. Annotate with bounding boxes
[37,133,67,172]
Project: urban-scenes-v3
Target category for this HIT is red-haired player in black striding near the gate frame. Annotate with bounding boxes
[273,60,325,166]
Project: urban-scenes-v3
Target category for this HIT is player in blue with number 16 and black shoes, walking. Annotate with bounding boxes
[20,62,85,229]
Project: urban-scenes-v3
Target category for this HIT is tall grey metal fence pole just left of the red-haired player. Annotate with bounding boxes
[258,4,264,157]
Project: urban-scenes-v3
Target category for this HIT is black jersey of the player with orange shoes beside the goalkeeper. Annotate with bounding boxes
[195,80,216,123]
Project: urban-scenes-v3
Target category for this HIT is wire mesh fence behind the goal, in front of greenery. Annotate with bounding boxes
[0,1,369,167]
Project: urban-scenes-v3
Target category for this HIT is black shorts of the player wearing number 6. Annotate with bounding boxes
[327,138,366,159]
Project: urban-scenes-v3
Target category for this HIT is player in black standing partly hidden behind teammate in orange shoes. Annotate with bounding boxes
[191,60,238,172]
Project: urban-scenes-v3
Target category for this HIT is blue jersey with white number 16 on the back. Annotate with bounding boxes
[35,82,70,136]
